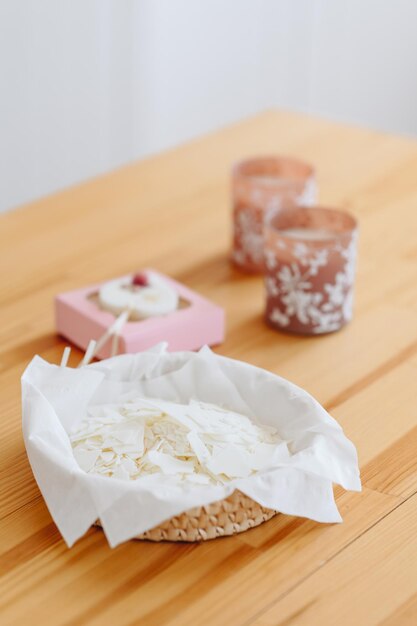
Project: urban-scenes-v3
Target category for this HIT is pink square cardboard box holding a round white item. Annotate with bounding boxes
[55,269,225,359]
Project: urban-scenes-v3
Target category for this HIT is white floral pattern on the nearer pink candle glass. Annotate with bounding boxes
[265,232,357,334]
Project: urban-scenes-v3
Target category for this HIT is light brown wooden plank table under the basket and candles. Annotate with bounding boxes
[0,112,417,626]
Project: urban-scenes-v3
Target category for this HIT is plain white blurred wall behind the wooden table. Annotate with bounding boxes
[0,0,417,210]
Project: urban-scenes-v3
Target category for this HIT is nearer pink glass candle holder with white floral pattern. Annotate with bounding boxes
[265,206,357,335]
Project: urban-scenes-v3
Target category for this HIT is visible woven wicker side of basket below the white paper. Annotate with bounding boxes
[98,491,277,542]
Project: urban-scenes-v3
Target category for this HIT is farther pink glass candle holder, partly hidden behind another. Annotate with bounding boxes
[232,157,316,272]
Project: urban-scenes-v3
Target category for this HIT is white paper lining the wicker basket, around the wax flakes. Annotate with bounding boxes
[22,344,361,546]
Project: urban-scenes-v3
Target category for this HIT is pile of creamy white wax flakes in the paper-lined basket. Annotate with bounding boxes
[71,398,288,484]
